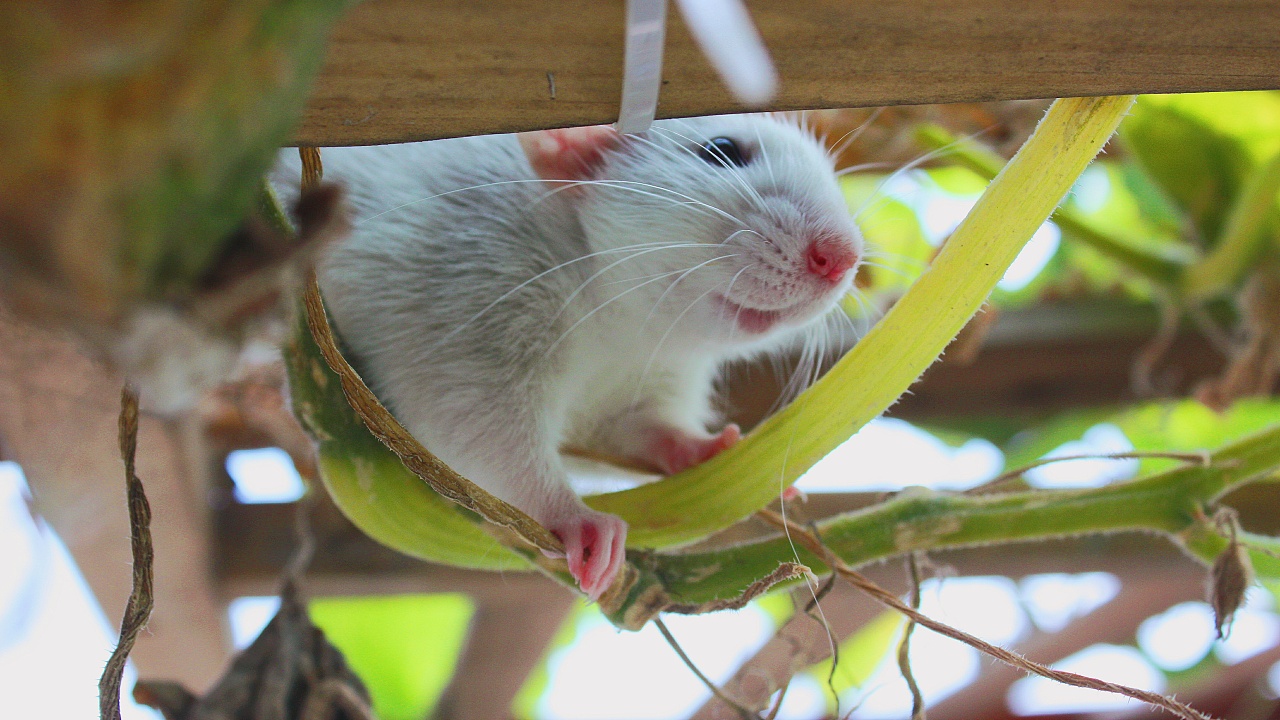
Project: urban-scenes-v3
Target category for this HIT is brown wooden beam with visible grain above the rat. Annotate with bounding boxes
[296,0,1280,146]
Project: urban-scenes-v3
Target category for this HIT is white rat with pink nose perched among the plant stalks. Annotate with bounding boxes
[275,115,863,598]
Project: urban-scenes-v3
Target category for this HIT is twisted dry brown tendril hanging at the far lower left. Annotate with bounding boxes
[97,384,154,720]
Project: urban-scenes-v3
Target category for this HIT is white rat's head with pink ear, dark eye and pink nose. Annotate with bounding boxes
[522,115,863,343]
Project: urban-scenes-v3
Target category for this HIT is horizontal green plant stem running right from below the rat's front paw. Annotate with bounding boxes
[637,425,1280,602]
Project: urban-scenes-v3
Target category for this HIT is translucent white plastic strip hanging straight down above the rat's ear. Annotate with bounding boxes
[617,0,667,133]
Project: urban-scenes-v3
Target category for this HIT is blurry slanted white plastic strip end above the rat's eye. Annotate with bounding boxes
[675,0,778,106]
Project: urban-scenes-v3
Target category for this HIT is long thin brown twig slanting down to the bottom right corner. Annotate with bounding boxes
[756,510,1211,720]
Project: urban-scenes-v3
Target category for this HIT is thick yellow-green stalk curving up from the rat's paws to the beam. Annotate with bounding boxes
[588,96,1134,547]
